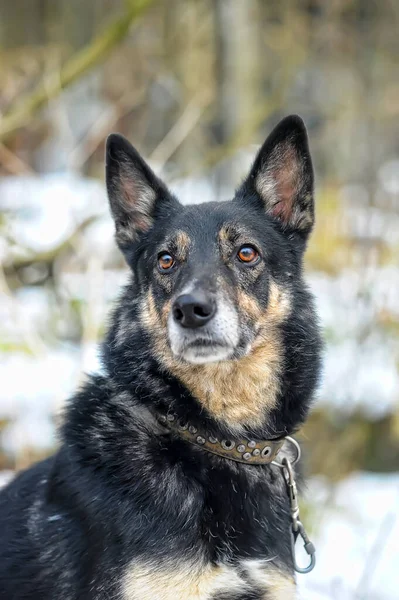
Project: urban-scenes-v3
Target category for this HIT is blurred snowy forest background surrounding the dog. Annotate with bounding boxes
[0,0,399,600]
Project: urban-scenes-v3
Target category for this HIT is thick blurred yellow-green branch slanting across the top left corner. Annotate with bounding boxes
[0,0,153,140]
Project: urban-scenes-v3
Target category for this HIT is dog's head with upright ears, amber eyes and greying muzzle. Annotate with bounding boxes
[106,116,322,428]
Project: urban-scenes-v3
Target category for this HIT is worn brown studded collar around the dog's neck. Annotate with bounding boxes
[157,412,286,465]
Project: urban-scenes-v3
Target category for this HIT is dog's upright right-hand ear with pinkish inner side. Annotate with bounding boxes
[243,115,314,239]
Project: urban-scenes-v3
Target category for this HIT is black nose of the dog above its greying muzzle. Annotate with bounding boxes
[173,291,215,329]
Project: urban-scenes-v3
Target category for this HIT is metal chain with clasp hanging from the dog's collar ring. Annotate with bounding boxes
[272,437,316,573]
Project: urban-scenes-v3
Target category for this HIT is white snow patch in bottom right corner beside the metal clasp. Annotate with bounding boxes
[298,473,399,600]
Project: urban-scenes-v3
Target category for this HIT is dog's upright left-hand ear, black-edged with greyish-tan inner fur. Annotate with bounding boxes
[105,133,178,251]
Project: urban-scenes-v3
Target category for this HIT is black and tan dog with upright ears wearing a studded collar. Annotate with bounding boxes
[0,115,321,600]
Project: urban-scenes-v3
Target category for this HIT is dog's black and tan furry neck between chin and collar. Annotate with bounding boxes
[103,285,319,439]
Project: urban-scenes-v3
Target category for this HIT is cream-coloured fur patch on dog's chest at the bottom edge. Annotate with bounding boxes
[122,560,295,600]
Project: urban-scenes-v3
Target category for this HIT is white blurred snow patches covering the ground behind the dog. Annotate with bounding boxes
[0,175,399,600]
